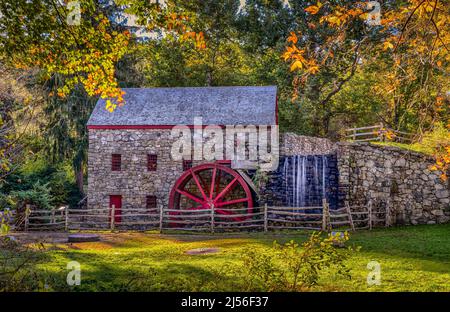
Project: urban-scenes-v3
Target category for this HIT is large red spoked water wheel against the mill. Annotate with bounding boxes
[169,163,253,221]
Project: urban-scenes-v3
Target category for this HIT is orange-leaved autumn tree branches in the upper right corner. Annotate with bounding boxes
[283,0,450,171]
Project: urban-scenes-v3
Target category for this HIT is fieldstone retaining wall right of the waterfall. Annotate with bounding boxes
[338,143,450,224]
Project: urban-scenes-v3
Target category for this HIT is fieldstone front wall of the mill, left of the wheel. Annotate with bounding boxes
[88,130,178,209]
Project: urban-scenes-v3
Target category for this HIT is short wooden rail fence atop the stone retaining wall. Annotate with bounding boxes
[345,124,415,143]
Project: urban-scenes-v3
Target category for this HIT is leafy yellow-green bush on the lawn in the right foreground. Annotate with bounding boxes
[235,233,359,291]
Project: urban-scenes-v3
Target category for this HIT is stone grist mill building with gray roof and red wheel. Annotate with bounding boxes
[87,86,277,222]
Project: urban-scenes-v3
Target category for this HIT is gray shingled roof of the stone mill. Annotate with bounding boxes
[88,86,277,126]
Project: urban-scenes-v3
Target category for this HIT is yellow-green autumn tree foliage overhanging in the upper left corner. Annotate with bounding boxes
[0,0,130,111]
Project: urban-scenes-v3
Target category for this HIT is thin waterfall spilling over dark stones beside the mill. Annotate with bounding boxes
[283,155,328,207]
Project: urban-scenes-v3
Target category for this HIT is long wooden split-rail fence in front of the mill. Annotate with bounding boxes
[8,200,390,233]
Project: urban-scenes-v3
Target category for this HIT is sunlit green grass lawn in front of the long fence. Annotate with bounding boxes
[4,224,450,291]
